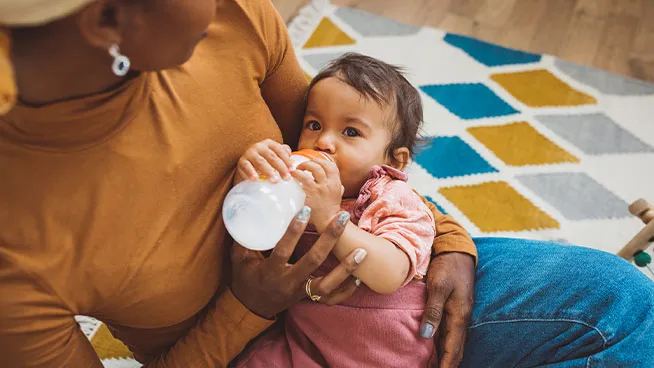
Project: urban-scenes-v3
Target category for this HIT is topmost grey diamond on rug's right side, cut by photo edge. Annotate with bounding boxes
[554,59,654,96]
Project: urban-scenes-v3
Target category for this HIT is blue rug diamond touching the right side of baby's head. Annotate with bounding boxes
[416,137,497,179]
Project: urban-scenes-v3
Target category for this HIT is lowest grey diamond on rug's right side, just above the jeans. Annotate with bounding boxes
[517,173,629,220]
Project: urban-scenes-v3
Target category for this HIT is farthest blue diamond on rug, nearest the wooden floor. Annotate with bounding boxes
[444,33,541,66]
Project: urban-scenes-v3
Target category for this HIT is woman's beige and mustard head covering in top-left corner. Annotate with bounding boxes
[0,0,93,115]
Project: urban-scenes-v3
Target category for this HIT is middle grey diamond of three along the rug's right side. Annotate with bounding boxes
[536,113,654,155]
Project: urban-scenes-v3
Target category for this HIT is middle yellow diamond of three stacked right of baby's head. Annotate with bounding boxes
[468,121,579,166]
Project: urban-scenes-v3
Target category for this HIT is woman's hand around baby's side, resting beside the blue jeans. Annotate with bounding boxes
[420,253,475,368]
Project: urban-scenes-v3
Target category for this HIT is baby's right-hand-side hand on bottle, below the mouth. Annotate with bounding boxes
[292,160,343,233]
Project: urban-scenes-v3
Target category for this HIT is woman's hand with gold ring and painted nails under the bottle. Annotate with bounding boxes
[231,207,366,318]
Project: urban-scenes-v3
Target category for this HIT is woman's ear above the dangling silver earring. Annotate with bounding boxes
[77,0,122,50]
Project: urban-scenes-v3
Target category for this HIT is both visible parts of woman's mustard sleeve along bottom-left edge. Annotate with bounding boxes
[0,252,272,368]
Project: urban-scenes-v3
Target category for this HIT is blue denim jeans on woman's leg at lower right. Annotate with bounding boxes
[461,238,654,368]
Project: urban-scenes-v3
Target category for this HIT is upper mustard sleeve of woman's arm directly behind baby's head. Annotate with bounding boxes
[255,0,309,149]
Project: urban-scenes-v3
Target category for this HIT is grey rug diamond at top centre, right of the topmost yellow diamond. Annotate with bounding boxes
[336,8,420,36]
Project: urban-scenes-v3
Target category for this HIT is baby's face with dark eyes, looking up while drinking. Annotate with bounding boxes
[299,77,393,198]
